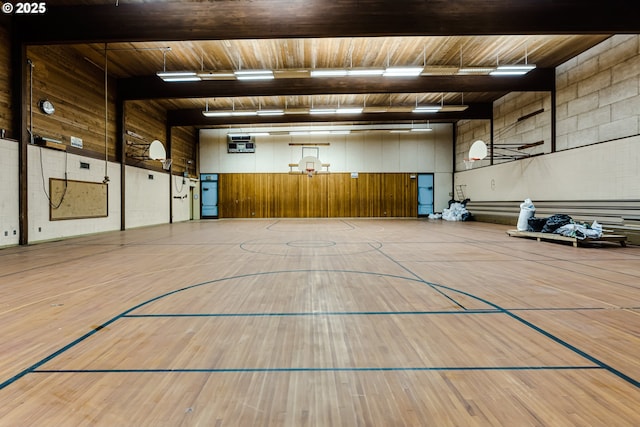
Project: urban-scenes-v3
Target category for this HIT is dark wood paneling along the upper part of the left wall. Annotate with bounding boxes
[20,45,197,176]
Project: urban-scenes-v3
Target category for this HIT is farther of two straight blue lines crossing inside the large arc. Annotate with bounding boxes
[122,309,503,318]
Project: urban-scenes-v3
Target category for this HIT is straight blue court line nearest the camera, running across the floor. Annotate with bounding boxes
[33,365,602,374]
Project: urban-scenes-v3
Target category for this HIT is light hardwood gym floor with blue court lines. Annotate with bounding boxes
[0,218,640,427]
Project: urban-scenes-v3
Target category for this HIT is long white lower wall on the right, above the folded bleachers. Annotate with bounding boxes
[455,136,640,204]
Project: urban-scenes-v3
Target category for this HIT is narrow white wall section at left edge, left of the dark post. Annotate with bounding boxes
[0,139,20,247]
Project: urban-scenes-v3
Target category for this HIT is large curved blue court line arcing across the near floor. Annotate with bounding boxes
[0,267,640,390]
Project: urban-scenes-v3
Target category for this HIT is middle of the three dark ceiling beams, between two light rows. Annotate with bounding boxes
[118,69,555,100]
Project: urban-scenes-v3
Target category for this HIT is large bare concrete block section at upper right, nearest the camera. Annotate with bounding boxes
[556,35,640,151]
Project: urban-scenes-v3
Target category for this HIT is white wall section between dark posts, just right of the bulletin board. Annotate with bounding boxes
[125,166,170,228]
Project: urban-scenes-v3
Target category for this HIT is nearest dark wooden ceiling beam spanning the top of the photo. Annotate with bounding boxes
[13,0,640,44]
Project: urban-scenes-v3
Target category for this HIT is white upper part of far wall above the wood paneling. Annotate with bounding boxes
[200,124,453,211]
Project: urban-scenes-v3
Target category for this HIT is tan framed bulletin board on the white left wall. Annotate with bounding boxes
[49,178,109,221]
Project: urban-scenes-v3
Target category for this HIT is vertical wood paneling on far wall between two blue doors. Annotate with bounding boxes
[218,173,418,218]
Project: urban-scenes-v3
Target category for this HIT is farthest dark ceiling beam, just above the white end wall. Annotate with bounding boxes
[167,103,493,127]
